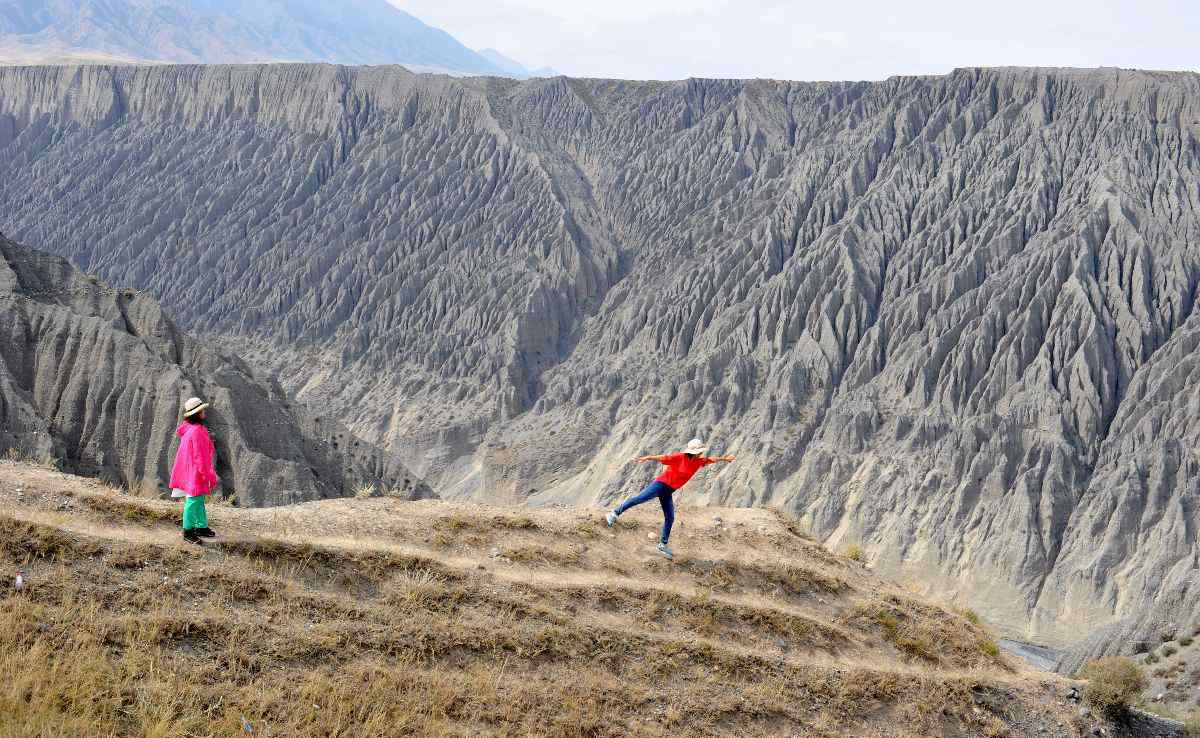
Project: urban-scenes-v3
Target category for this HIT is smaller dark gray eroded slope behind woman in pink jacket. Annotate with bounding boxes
[0,236,432,505]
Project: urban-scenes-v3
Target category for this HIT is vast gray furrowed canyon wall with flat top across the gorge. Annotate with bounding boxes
[0,66,1200,647]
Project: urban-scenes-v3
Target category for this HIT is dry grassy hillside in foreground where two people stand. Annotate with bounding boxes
[0,462,1098,738]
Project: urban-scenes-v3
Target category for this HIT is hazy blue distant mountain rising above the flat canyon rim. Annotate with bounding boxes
[0,0,504,74]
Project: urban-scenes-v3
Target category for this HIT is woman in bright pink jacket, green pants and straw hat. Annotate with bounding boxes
[170,397,221,544]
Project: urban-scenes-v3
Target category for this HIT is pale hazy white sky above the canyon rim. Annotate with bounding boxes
[391,0,1200,80]
